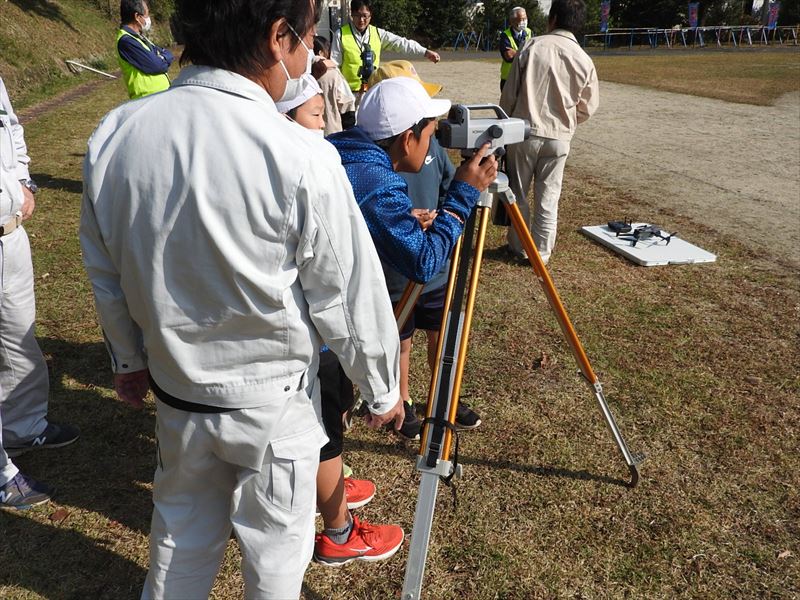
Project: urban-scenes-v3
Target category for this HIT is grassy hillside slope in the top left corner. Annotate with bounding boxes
[0,0,169,109]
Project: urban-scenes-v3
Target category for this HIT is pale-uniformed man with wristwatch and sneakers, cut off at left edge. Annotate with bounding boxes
[0,72,78,508]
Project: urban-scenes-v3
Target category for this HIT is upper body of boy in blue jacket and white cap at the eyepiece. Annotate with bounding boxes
[328,77,497,437]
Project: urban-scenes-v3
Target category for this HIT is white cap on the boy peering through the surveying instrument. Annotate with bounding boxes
[356,77,450,141]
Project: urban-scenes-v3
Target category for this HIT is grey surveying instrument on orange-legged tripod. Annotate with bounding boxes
[395,104,644,600]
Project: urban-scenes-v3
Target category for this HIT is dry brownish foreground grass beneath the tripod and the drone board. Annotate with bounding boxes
[0,58,800,600]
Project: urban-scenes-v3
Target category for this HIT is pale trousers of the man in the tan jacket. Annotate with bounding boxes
[507,137,569,264]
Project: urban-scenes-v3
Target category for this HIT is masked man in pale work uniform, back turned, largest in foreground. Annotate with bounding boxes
[80,0,404,598]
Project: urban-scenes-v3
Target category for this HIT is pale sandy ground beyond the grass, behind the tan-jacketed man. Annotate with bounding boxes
[415,60,800,267]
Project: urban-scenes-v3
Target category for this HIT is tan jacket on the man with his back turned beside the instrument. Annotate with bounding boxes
[500,29,600,141]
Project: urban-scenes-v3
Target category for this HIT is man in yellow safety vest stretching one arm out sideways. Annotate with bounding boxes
[331,0,441,92]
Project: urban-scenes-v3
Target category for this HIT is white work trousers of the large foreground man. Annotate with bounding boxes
[142,377,327,600]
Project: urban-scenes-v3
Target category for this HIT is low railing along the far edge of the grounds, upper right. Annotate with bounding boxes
[583,25,800,49]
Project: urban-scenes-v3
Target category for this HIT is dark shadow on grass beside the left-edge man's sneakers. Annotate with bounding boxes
[15,338,155,533]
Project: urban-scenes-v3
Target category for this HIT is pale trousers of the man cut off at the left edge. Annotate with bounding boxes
[0,227,50,484]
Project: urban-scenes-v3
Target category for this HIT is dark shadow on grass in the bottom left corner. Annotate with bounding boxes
[0,509,146,600]
